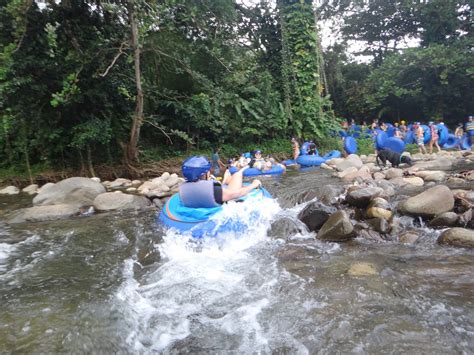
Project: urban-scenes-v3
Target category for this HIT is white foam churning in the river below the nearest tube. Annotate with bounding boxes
[116,199,312,352]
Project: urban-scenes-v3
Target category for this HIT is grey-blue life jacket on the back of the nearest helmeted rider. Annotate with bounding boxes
[179,180,220,208]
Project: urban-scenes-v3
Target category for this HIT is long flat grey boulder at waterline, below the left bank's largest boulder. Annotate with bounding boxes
[6,204,80,223]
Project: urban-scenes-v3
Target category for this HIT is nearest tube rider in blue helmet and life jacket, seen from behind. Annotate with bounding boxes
[179,156,262,208]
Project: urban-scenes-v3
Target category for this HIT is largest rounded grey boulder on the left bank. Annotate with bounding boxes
[33,177,105,207]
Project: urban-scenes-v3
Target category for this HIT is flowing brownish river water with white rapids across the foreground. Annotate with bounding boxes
[0,171,474,354]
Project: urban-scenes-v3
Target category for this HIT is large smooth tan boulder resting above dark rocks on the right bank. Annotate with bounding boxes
[399,185,454,217]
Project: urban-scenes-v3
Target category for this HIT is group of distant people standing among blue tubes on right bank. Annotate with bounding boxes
[341,116,474,154]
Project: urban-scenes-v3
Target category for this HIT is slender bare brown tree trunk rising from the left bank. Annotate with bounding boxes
[125,0,143,166]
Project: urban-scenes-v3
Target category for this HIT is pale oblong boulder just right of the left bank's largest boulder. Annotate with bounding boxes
[94,192,151,211]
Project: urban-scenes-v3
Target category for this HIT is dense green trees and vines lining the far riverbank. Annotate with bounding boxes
[0,0,474,174]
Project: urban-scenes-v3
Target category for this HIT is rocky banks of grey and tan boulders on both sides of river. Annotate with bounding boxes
[0,151,474,248]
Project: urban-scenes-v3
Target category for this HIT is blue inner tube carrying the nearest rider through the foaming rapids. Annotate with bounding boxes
[157,188,272,238]
